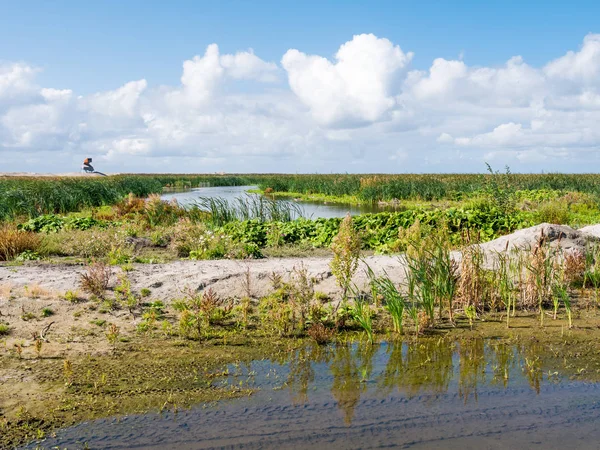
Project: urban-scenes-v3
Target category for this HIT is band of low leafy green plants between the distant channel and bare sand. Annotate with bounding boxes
[0,175,600,266]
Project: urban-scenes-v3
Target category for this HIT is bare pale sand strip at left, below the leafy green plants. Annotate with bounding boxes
[0,256,404,355]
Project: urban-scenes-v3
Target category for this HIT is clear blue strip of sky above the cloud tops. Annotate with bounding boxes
[0,0,600,94]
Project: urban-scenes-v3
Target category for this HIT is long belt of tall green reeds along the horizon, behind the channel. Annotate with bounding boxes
[5,173,600,221]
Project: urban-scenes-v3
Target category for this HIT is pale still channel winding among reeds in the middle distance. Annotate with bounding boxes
[161,186,389,219]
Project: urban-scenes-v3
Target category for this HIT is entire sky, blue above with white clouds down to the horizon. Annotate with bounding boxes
[0,0,600,173]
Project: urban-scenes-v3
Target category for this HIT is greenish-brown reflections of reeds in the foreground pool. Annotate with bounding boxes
[274,338,576,425]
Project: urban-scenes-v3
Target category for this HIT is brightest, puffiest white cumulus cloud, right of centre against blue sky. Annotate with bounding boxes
[281,34,412,127]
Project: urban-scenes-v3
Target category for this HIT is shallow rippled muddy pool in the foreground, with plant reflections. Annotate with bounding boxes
[28,339,600,450]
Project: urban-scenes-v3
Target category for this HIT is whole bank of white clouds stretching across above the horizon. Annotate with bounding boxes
[0,34,600,172]
